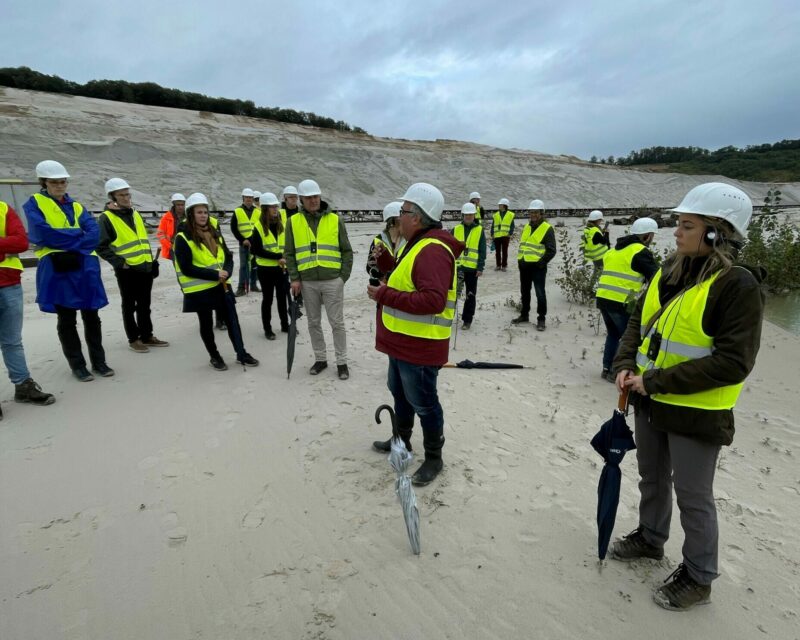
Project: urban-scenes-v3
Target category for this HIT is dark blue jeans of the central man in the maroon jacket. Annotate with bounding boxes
[387,356,444,458]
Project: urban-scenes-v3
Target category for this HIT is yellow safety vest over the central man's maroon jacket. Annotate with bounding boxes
[381,238,456,340]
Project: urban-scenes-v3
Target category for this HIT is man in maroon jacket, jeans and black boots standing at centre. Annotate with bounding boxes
[367,182,464,485]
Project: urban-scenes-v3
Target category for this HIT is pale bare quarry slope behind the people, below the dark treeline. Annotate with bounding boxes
[0,88,800,210]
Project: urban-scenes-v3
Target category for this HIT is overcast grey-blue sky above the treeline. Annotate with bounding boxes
[6,0,800,159]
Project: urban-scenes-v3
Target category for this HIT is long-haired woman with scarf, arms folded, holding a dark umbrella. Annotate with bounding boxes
[173,193,258,371]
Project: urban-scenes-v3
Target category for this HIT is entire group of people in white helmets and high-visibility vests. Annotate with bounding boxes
[0,168,764,610]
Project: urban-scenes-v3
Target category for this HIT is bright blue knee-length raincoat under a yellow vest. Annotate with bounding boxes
[22,190,108,313]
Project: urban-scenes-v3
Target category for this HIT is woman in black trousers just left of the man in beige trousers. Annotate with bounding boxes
[250,192,289,340]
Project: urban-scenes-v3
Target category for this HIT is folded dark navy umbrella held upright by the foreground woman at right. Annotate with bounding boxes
[592,389,636,560]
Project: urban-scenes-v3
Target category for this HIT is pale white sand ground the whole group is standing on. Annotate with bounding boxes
[0,225,800,640]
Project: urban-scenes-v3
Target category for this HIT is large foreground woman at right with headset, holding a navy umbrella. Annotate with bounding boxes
[611,182,764,611]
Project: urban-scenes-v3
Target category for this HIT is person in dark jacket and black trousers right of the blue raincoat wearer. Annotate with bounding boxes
[97,178,169,353]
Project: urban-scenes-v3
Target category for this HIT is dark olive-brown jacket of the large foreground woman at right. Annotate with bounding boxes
[613,263,766,445]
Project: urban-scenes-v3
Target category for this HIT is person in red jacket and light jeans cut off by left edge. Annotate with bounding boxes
[0,202,56,420]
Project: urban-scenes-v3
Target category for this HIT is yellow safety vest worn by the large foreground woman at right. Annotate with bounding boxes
[636,269,744,410]
